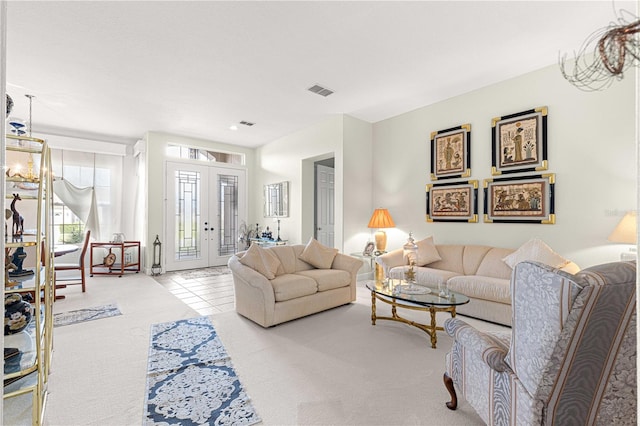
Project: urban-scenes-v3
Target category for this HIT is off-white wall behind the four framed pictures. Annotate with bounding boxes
[370,65,636,267]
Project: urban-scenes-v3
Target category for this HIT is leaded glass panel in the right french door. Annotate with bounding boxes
[218,175,238,256]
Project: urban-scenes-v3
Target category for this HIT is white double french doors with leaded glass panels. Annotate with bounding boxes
[165,161,247,271]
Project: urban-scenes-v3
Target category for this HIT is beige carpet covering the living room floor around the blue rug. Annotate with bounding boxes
[38,274,510,426]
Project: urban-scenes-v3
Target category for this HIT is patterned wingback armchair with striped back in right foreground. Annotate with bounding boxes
[444,262,637,425]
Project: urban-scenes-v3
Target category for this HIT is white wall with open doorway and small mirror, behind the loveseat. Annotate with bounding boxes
[252,115,372,253]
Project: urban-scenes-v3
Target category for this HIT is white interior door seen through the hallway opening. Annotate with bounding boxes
[316,164,335,247]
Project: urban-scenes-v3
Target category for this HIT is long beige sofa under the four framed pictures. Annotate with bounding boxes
[376,238,580,326]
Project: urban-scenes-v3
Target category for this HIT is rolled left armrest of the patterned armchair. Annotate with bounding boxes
[444,318,511,372]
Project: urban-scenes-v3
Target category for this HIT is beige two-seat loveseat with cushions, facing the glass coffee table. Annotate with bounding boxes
[228,240,362,327]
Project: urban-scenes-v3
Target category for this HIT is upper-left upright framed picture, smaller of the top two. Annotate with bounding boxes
[431,124,471,180]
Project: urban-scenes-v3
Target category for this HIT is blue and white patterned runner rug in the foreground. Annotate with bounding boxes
[144,317,261,426]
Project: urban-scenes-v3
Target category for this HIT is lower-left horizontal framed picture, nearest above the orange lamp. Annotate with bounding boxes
[427,180,478,223]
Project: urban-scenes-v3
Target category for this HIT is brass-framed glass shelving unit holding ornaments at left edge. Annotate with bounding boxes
[2,135,54,425]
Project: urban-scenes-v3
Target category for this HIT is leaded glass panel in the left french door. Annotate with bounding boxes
[175,170,201,260]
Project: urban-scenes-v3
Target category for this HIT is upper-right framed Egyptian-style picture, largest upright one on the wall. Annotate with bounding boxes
[491,107,548,176]
